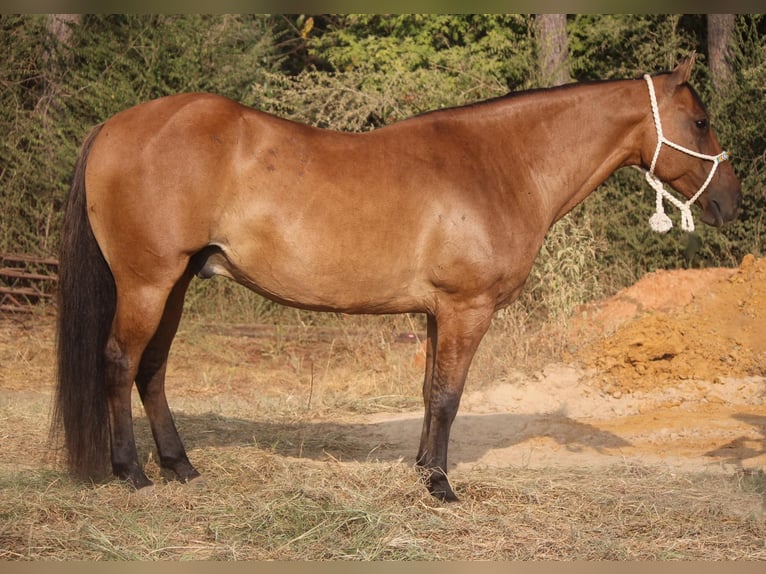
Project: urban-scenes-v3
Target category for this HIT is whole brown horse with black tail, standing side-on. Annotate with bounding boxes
[51,56,742,501]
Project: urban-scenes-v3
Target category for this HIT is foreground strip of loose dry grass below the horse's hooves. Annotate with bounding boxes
[0,456,766,560]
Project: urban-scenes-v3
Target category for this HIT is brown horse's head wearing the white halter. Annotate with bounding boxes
[642,56,742,228]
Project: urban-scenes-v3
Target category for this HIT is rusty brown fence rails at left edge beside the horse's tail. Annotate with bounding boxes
[0,253,58,313]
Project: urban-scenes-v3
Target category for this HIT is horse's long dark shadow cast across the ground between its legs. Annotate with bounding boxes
[152,413,630,464]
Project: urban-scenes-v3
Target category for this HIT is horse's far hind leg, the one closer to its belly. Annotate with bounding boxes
[136,271,200,482]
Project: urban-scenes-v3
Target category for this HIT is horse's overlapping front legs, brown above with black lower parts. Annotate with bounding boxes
[417,305,494,501]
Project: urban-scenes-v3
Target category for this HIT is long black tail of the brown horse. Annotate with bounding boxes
[50,126,116,480]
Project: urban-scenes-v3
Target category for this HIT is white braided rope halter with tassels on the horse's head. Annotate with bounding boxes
[644,74,730,233]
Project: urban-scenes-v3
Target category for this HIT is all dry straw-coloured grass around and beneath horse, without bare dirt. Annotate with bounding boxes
[0,318,766,560]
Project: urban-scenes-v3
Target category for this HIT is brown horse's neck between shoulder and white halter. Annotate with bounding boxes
[490,81,651,223]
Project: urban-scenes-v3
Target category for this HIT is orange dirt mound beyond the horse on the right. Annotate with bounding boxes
[572,255,766,393]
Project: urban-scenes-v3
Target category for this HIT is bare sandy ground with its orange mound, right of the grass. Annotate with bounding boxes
[332,256,766,482]
